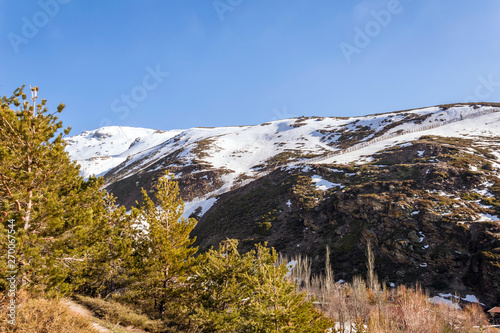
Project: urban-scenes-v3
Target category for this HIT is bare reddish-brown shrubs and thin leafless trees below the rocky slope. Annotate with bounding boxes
[289,245,497,333]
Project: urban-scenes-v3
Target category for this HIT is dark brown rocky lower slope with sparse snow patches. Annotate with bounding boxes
[190,137,500,303]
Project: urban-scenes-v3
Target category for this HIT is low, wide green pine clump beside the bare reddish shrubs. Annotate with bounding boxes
[190,240,332,332]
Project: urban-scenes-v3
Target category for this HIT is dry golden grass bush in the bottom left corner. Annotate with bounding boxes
[0,292,99,333]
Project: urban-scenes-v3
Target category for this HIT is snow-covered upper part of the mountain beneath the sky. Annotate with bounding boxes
[66,105,500,187]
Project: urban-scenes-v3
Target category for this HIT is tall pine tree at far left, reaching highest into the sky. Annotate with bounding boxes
[0,86,103,292]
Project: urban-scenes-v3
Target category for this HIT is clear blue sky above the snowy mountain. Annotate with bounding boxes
[0,0,500,135]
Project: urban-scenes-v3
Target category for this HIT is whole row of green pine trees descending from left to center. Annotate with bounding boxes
[0,86,331,332]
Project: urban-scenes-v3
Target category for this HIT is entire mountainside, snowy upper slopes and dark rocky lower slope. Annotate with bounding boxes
[66,104,500,304]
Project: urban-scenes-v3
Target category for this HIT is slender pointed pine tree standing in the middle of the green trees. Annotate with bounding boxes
[132,172,197,317]
